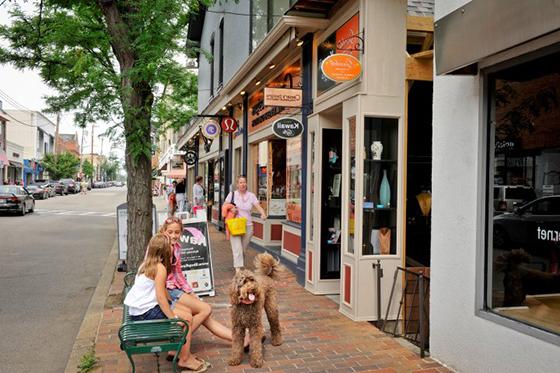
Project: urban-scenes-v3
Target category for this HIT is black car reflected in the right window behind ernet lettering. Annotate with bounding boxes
[493,195,560,250]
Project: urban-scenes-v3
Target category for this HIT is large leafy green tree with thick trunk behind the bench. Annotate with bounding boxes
[0,0,213,269]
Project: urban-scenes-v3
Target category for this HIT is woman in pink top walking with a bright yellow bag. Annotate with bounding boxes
[222,175,267,273]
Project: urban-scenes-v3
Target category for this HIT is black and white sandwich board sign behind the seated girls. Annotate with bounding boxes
[180,219,216,296]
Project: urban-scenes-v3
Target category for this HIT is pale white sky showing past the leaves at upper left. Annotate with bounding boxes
[0,1,124,159]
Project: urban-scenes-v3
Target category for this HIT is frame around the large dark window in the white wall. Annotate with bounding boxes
[474,40,560,346]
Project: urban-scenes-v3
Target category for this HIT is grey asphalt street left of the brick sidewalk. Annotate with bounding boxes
[0,187,126,373]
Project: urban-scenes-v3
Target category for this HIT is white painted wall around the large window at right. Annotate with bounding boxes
[430,0,560,373]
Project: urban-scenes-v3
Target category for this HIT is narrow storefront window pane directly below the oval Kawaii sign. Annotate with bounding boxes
[286,137,301,224]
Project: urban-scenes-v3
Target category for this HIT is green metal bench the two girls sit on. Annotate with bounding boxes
[119,273,189,373]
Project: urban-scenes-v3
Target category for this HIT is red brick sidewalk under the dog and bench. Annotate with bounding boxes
[95,227,450,373]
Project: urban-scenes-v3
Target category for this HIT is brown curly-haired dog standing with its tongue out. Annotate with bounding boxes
[229,254,283,368]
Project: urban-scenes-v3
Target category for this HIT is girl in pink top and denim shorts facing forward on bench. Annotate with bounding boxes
[159,217,249,356]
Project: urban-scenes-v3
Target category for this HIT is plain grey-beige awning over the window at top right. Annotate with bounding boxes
[435,0,560,75]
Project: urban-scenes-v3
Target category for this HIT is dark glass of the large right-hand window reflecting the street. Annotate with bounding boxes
[486,48,560,334]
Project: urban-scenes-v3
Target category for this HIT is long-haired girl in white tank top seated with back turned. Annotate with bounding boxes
[124,234,207,372]
